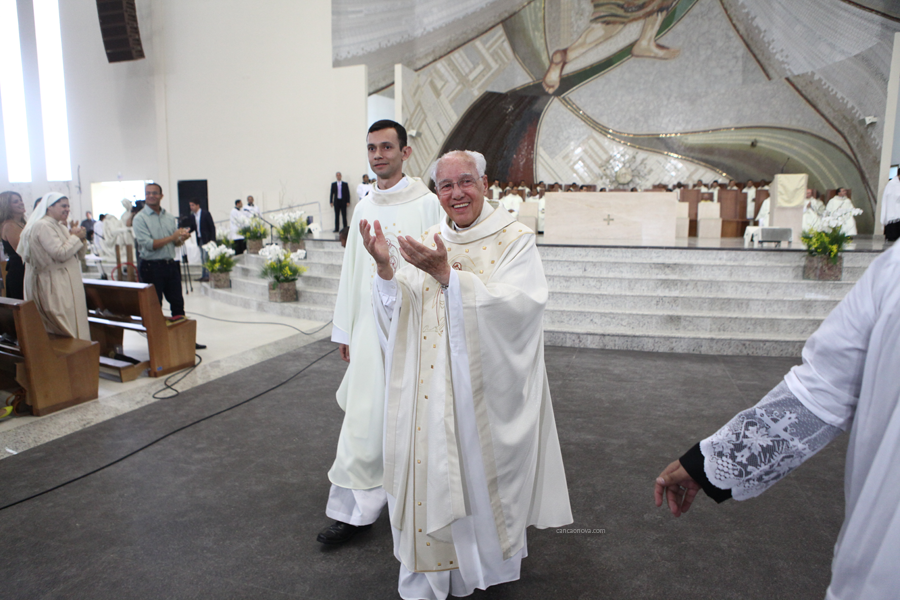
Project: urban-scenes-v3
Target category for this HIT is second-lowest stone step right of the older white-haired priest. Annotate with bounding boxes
[544,309,822,339]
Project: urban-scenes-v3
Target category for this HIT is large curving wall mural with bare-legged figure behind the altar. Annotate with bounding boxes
[332,0,900,233]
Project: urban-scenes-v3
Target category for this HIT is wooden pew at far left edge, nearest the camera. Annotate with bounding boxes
[0,298,100,416]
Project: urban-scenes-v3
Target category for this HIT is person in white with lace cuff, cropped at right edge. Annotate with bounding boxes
[655,247,900,600]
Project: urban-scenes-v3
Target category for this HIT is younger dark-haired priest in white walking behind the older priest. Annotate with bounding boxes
[316,120,441,544]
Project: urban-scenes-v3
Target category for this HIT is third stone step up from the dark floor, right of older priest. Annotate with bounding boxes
[547,291,838,318]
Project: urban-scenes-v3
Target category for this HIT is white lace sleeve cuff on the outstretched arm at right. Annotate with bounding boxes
[700,381,841,500]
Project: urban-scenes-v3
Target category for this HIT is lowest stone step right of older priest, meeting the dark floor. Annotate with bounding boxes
[544,328,806,356]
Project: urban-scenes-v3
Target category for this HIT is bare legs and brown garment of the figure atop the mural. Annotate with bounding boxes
[543,0,681,94]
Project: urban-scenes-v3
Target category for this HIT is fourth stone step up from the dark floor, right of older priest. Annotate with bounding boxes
[547,275,853,300]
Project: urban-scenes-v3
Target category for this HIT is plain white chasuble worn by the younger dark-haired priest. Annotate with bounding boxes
[328,178,443,490]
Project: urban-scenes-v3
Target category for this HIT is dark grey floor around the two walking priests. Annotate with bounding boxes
[0,342,845,600]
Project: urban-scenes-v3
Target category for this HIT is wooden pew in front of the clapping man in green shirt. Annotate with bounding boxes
[84,279,197,381]
